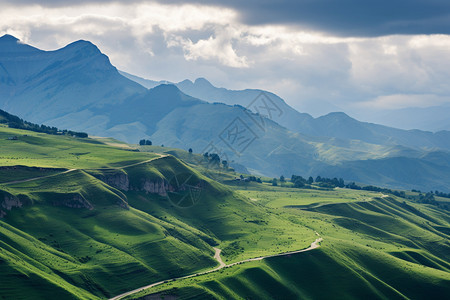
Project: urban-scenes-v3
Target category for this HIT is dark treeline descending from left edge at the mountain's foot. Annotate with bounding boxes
[0,110,88,138]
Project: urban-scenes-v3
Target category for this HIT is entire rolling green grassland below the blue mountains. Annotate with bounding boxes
[0,127,450,299]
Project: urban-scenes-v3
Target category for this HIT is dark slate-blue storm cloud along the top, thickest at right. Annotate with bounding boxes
[0,0,450,37]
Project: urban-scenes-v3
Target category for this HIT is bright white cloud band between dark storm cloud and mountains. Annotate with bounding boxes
[0,3,450,118]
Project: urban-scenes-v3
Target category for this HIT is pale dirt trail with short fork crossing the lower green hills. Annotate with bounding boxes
[109,237,323,300]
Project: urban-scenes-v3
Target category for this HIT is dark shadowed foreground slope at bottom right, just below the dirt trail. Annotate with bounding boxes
[129,240,450,299]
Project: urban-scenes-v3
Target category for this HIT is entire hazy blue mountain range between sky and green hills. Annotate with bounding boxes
[0,35,450,191]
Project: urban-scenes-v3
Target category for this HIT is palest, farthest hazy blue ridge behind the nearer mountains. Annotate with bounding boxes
[124,74,450,150]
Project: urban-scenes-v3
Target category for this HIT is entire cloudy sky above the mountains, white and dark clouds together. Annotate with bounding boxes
[0,0,450,119]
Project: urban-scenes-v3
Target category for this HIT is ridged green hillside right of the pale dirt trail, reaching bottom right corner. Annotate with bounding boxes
[129,188,450,299]
